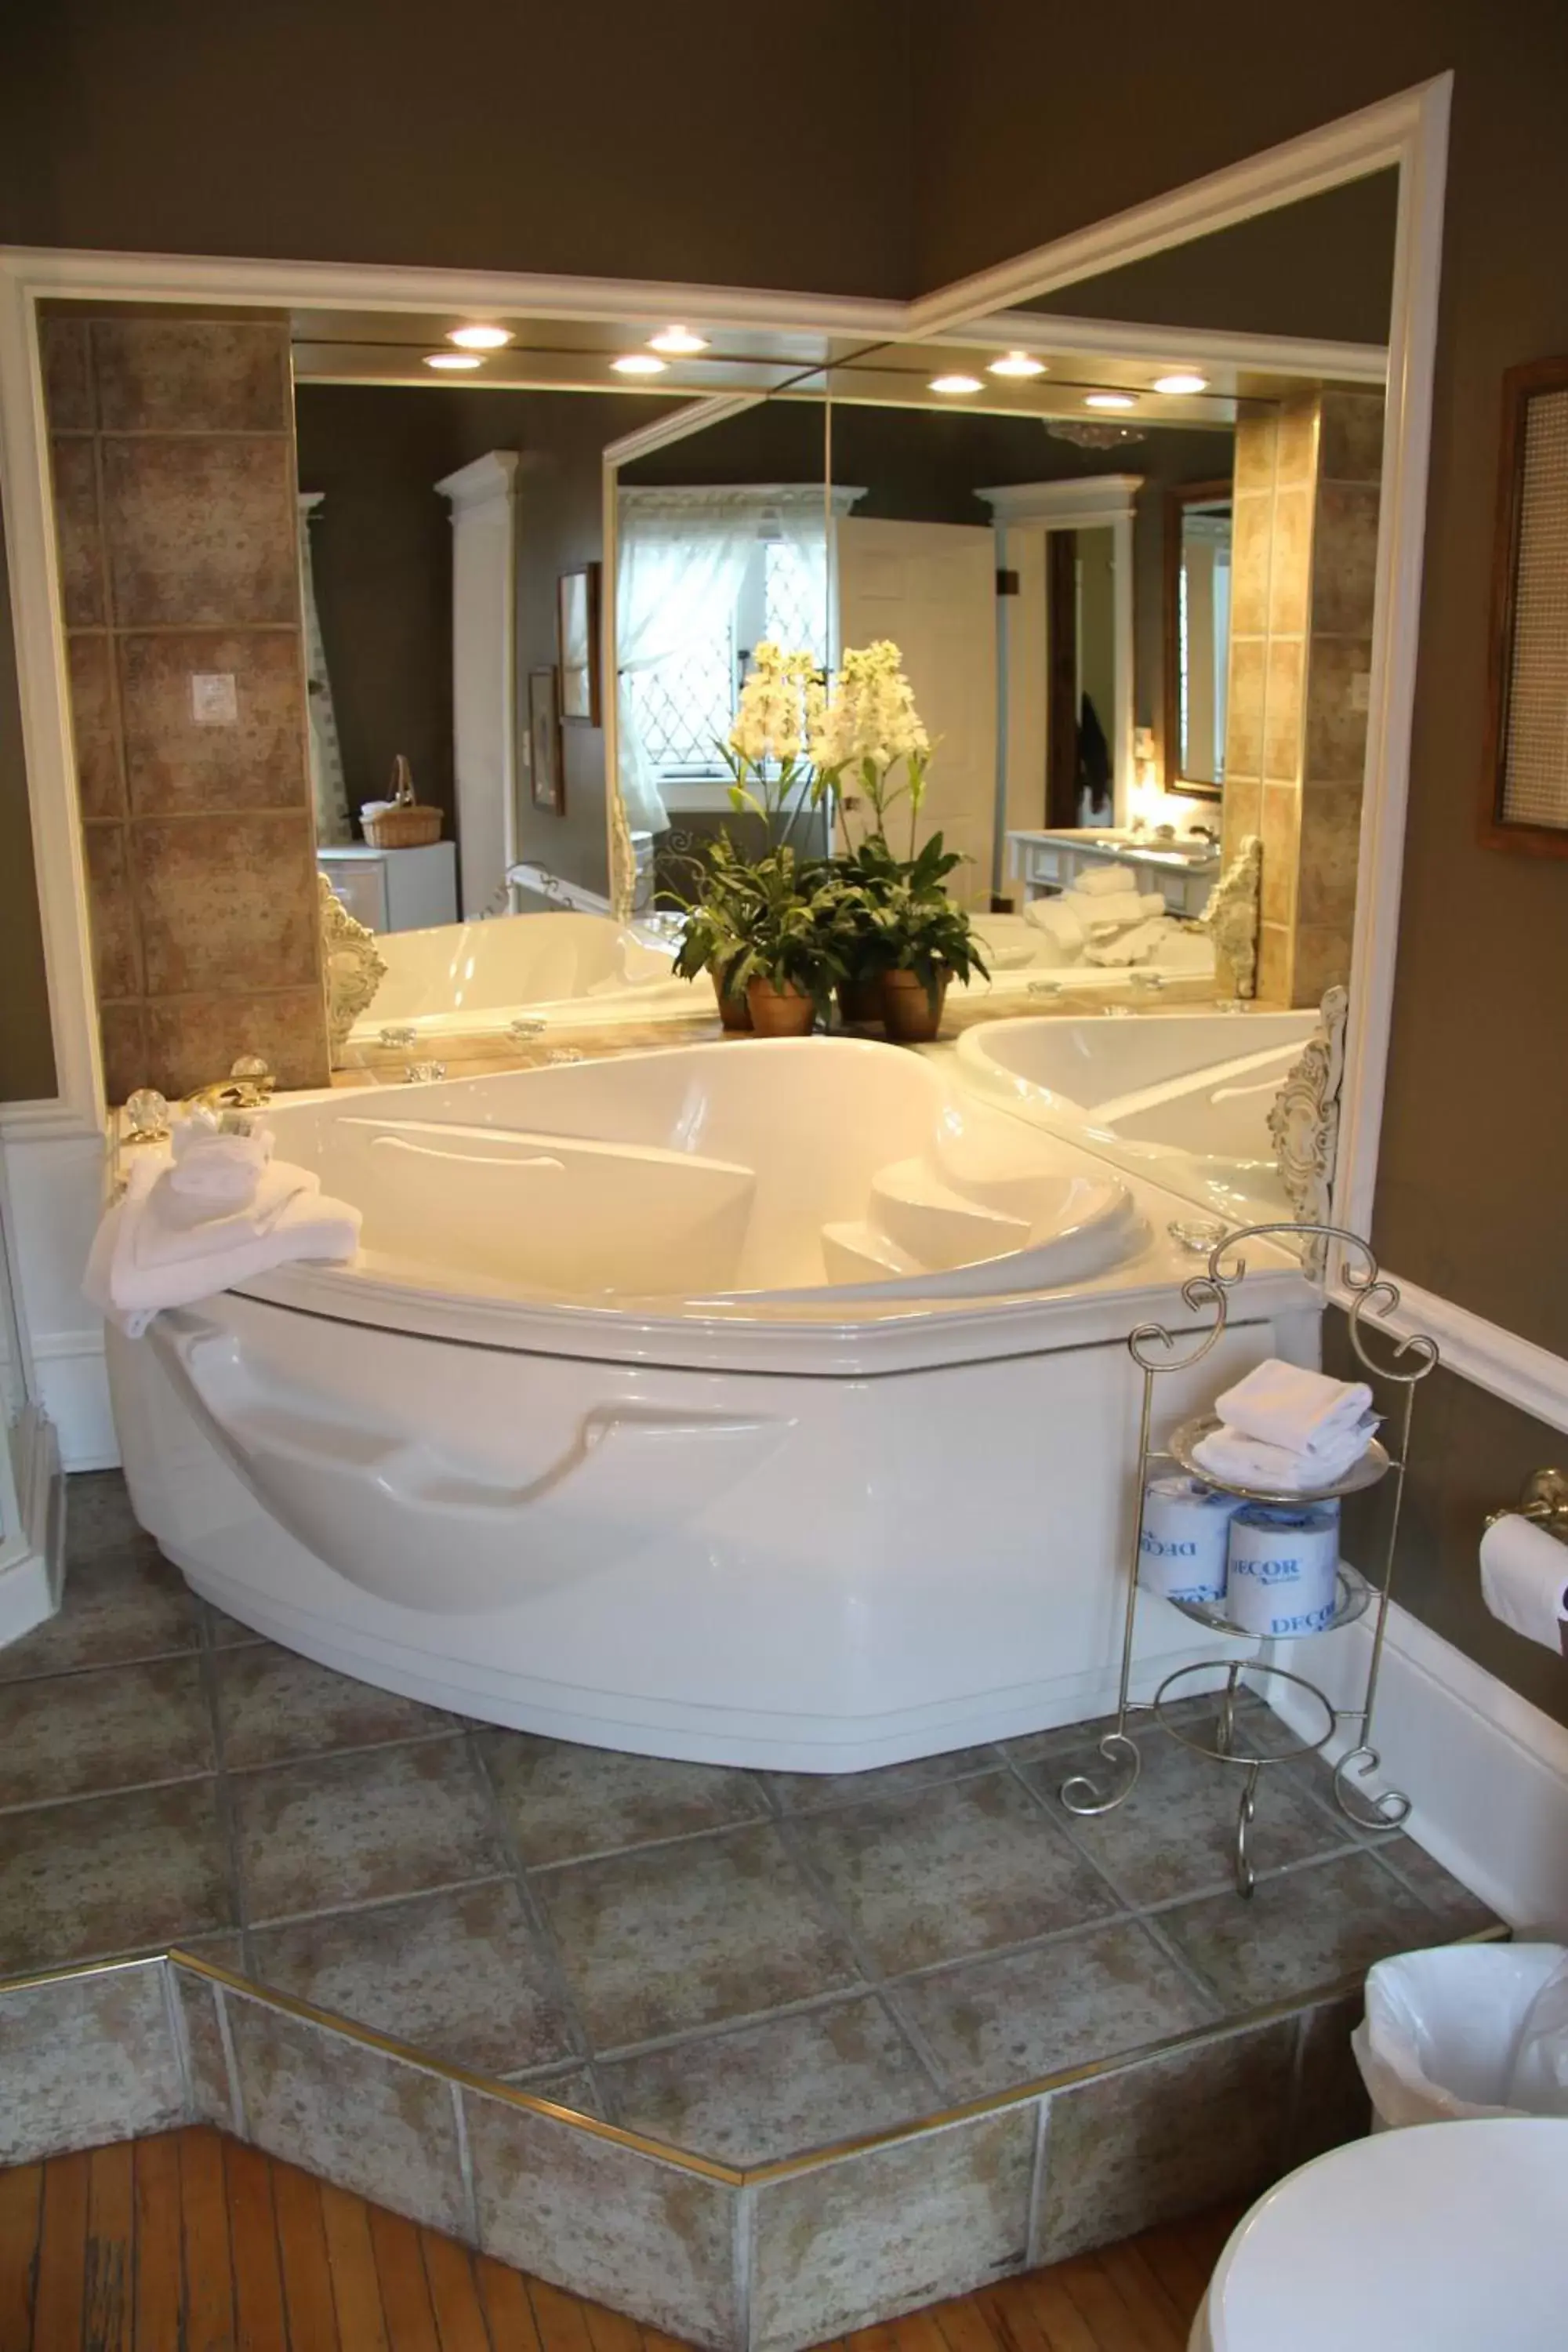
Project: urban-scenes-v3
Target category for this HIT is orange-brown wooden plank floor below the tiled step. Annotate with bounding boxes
[0,2131,1239,2352]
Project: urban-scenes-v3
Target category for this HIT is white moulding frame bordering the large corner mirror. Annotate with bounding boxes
[0,75,1450,1289]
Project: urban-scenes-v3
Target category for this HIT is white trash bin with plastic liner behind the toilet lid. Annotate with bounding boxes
[1349,1943,1568,2131]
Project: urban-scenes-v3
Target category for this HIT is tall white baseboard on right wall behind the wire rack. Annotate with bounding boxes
[1269,1604,1568,1938]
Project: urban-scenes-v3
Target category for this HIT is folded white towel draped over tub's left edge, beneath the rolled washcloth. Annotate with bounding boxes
[82,1157,360,1338]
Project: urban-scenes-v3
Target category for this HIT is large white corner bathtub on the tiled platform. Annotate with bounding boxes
[108,1040,1316,1771]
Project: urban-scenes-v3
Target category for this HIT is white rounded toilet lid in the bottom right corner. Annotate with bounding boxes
[1187,2117,1568,2352]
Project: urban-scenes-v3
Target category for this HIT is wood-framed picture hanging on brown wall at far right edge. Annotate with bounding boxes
[1481,360,1568,858]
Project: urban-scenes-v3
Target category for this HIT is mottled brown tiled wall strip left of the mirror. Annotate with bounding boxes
[45,308,327,1103]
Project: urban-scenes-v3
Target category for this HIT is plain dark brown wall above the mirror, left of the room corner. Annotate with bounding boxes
[0,0,909,294]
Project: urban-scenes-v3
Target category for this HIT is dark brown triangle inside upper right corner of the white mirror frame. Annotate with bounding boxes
[1022,172,1399,343]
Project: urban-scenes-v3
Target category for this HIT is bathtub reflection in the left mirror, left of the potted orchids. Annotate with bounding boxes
[350,913,706,1044]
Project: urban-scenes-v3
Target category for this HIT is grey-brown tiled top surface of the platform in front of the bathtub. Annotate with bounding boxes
[0,1475,1488,2164]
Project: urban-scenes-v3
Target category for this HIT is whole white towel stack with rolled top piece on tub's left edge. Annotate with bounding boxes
[82,1112,360,1338]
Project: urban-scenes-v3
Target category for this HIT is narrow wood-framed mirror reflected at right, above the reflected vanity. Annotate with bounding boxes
[1163,477,1232,800]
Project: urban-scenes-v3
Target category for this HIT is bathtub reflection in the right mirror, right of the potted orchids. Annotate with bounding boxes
[956,1011,1319,1225]
